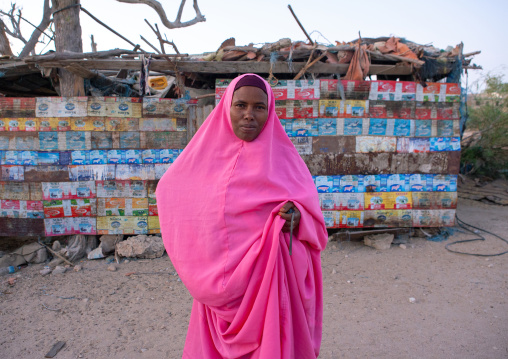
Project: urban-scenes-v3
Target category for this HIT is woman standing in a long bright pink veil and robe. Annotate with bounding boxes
[156,74,327,359]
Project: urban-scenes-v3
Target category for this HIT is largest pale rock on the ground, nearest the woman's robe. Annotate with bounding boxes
[116,234,165,258]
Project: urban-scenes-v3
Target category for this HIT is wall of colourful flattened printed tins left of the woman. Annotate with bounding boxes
[0,97,188,236]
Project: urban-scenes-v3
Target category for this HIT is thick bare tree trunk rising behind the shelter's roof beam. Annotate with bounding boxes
[52,0,85,96]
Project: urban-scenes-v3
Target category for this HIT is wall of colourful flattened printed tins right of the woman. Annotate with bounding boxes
[216,80,461,228]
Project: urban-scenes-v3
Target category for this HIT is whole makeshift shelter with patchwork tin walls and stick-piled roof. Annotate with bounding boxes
[0,38,477,236]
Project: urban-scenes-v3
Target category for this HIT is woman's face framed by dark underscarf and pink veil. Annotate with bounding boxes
[230,86,268,142]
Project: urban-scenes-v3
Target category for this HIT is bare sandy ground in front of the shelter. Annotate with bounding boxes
[0,200,508,359]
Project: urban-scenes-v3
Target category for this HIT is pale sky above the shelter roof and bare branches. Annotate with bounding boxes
[0,0,508,90]
